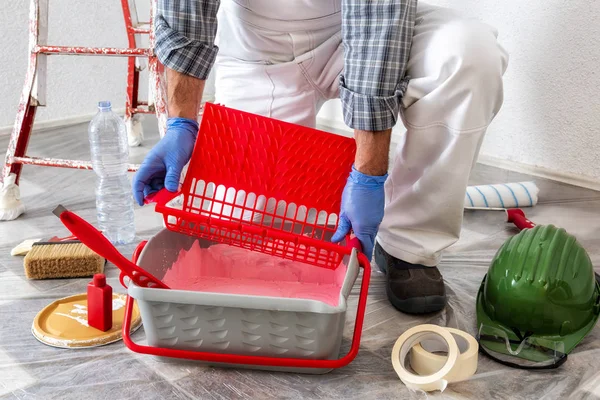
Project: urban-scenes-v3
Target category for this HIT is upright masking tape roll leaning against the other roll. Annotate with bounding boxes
[392,324,459,392]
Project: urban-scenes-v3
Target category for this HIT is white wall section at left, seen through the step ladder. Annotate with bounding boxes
[0,0,147,127]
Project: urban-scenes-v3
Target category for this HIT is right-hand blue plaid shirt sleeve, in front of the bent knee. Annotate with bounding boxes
[340,0,417,131]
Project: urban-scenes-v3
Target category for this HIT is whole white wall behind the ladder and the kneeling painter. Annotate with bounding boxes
[0,0,600,183]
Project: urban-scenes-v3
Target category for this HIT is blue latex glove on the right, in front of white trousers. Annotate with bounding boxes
[331,166,387,260]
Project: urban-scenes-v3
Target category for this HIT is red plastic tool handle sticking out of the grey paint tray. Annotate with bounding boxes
[53,205,169,289]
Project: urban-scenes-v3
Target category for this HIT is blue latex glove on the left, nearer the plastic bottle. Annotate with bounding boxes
[132,118,198,206]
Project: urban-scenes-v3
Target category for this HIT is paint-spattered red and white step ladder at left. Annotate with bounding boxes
[0,0,167,221]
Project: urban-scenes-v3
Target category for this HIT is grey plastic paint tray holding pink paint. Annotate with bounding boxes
[128,229,359,373]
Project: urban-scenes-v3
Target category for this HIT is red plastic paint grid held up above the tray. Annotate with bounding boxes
[158,104,355,268]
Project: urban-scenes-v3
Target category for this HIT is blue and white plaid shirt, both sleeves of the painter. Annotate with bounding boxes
[155,0,417,131]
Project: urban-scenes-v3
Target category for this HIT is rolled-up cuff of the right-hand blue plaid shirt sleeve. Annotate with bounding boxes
[340,76,408,131]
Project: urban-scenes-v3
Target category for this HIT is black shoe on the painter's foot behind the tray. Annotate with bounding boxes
[375,243,446,314]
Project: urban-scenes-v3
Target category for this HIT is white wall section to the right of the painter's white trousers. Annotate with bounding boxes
[321,0,600,187]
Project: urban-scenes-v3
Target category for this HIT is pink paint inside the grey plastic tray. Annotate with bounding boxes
[162,241,346,307]
